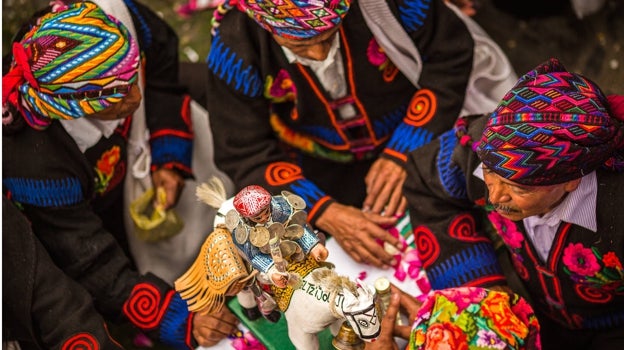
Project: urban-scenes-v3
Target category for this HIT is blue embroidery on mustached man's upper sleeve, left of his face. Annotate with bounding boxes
[436,130,466,199]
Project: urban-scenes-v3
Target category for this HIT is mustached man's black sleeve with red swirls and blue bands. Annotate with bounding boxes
[404,118,505,289]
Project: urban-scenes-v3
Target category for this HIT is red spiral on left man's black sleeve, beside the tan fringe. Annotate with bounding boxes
[124,283,161,329]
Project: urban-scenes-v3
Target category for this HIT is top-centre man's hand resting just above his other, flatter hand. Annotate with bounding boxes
[364,158,407,217]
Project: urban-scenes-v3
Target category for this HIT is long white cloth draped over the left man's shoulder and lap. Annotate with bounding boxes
[93,0,233,284]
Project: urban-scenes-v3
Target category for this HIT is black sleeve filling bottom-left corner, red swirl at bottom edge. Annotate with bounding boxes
[2,196,122,349]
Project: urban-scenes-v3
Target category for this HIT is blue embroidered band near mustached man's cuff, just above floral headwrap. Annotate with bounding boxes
[427,242,502,289]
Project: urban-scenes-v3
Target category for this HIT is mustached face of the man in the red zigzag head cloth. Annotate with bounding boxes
[483,165,581,221]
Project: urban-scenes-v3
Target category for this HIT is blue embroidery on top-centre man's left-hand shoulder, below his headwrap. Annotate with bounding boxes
[207,30,262,97]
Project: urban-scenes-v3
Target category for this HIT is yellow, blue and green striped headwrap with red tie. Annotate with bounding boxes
[2,2,139,130]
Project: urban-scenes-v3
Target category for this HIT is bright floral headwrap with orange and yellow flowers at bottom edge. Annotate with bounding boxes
[407,287,541,350]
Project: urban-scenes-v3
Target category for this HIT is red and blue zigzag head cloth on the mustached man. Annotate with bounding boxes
[477,59,624,186]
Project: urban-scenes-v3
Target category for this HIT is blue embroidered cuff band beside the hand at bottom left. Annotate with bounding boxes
[160,293,189,349]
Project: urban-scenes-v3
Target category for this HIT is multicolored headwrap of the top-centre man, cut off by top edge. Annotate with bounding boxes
[237,0,351,40]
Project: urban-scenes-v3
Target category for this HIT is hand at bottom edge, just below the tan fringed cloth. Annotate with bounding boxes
[192,306,239,347]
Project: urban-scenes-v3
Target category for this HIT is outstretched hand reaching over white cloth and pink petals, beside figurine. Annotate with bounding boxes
[316,203,401,268]
